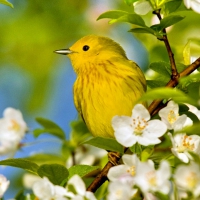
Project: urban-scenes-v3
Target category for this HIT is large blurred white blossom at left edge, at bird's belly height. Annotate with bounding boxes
[0,108,28,157]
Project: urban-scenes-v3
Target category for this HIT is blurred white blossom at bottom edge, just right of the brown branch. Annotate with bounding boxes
[107,181,137,200]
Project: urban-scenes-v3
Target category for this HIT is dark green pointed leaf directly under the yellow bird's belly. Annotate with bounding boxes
[83,137,124,154]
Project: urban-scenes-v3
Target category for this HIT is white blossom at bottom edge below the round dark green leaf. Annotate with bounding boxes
[33,177,67,200]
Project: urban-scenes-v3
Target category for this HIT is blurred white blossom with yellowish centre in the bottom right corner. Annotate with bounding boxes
[174,162,200,197]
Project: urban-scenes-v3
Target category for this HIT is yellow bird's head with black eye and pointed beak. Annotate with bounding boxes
[55,35,126,71]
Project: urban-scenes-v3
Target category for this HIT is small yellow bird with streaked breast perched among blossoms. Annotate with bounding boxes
[55,35,146,137]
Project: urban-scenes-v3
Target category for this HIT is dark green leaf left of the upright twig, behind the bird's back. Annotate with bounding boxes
[149,61,171,78]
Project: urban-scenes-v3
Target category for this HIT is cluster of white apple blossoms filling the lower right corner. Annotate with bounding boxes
[111,101,200,200]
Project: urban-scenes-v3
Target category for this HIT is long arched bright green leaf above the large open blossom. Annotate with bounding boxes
[138,87,197,105]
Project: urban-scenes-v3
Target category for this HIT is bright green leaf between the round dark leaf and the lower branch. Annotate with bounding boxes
[69,165,99,178]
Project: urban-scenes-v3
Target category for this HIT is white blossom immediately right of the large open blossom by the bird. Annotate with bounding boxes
[158,101,193,131]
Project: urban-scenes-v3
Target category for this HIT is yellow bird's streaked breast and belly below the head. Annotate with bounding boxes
[74,61,145,137]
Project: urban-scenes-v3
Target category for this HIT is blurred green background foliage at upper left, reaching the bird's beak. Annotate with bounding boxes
[0,0,90,110]
